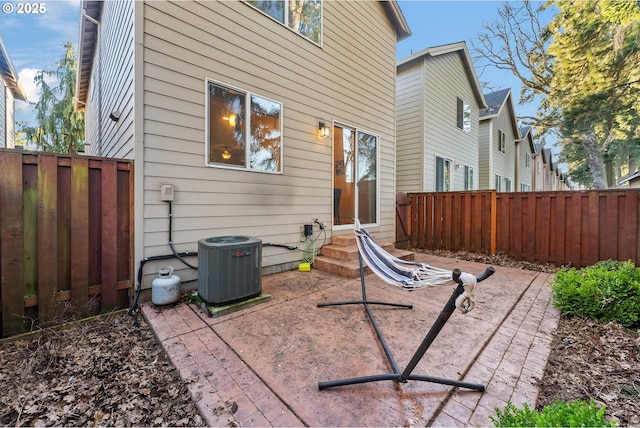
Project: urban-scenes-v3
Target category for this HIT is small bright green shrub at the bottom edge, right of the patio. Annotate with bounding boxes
[489,400,616,427]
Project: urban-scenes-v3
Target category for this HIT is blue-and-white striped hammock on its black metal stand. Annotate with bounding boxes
[317,221,495,392]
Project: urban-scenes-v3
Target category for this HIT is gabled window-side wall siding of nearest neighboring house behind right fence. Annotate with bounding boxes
[424,52,479,191]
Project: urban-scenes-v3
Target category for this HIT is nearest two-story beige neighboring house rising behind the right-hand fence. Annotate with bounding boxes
[396,42,487,192]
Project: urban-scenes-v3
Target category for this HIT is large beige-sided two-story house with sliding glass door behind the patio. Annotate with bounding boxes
[77,0,410,287]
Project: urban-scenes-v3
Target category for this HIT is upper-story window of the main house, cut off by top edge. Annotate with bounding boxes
[247,0,322,44]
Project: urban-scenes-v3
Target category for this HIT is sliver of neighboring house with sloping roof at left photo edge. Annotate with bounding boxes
[0,37,27,149]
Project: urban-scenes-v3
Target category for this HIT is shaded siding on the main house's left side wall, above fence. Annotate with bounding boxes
[85,1,135,159]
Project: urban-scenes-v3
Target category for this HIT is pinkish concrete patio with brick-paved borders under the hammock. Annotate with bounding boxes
[142,254,559,426]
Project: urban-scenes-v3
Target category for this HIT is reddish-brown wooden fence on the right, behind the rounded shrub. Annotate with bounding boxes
[404,189,640,267]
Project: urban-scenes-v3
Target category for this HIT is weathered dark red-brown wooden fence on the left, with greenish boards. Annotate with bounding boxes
[0,149,133,337]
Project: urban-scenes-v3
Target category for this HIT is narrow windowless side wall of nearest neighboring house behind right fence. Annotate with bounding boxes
[396,61,425,193]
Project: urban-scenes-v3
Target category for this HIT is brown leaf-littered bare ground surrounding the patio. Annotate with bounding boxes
[0,254,640,426]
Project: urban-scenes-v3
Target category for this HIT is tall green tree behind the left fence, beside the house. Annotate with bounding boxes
[19,42,84,153]
